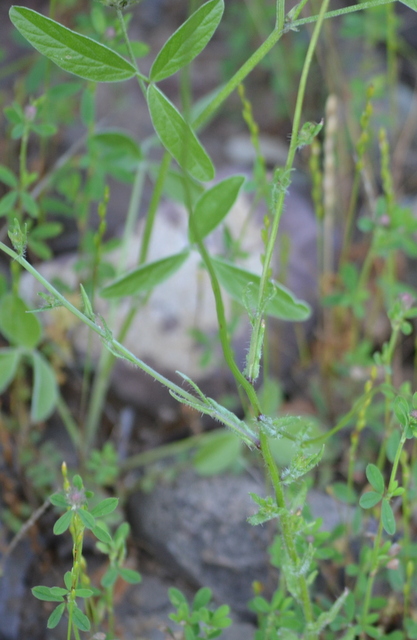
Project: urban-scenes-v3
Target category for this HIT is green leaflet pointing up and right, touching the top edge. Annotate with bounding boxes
[150,0,224,82]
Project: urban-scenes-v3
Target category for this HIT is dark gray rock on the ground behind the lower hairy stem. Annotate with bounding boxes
[129,471,350,616]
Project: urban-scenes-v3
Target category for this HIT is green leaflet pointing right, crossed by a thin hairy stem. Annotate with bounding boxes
[211,257,311,321]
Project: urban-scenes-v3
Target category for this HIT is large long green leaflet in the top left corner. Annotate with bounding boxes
[9,7,136,82]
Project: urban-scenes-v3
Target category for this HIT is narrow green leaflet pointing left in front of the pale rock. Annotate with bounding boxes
[100,249,189,298]
